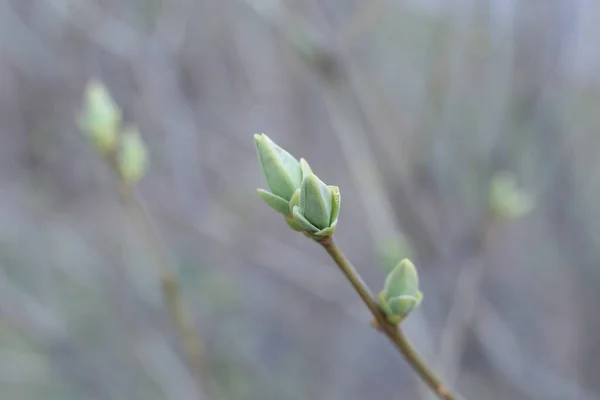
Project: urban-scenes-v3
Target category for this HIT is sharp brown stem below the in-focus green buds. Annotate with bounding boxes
[320,238,456,400]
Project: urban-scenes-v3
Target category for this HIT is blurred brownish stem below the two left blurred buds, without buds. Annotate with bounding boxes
[119,181,211,391]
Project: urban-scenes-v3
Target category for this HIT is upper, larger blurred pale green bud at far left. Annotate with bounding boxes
[79,80,121,155]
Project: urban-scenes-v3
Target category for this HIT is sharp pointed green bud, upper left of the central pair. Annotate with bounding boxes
[254,133,302,214]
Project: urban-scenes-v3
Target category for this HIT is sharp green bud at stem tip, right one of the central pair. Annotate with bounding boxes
[292,172,341,239]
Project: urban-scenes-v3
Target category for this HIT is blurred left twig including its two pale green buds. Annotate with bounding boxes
[78,80,212,390]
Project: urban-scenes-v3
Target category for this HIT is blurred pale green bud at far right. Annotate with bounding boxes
[489,172,534,220]
